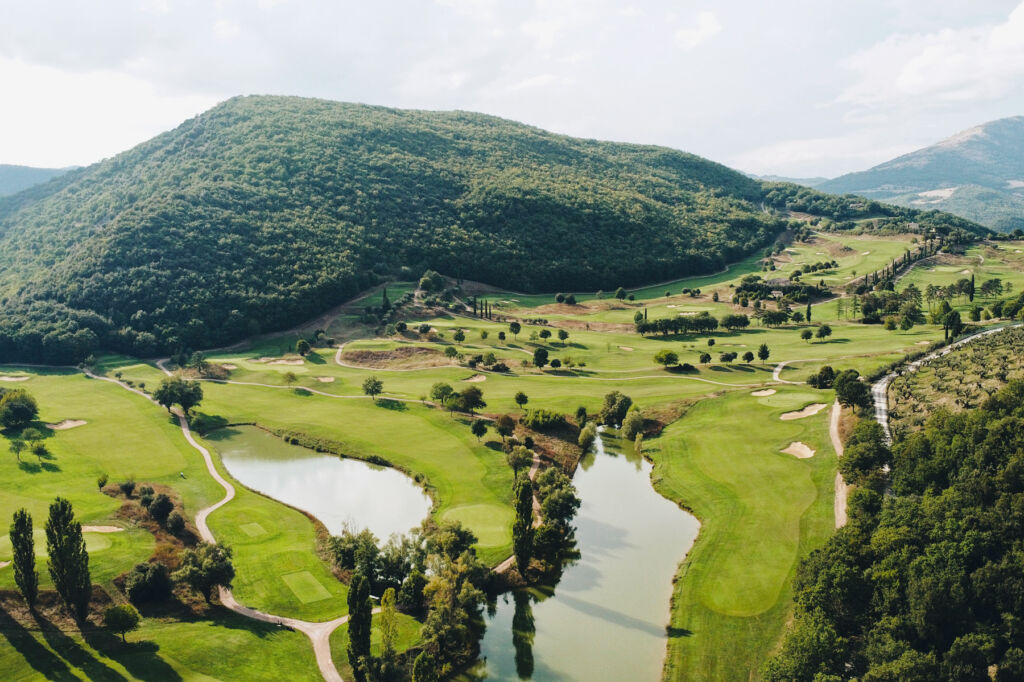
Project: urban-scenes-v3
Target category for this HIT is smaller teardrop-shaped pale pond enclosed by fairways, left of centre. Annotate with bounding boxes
[206,426,431,542]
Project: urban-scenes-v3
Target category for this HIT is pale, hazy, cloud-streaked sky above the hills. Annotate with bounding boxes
[0,0,1024,177]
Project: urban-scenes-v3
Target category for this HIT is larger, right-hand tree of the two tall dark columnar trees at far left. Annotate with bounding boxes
[46,498,92,622]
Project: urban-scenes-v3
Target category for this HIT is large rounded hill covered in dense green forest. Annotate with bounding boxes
[0,96,978,363]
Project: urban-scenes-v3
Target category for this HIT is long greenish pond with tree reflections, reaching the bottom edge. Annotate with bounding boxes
[468,428,700,682]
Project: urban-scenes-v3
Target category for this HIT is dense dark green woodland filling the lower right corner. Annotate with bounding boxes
[765,382,1024,682]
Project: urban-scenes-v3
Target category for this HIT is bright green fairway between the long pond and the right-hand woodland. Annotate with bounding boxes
[649,388,837,680]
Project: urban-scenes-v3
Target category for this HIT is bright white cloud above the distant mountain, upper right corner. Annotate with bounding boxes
[837,3,1024,109]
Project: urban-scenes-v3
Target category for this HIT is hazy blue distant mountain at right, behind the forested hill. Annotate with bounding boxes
[816,116,1024,232]
